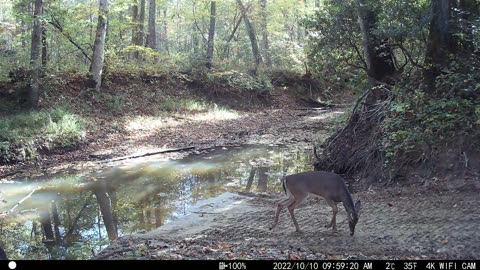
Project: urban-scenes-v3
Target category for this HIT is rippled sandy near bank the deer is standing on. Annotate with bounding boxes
[98,177,480,259]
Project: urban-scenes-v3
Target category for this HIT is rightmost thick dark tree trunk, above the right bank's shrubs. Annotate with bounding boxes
[424,0,456,92]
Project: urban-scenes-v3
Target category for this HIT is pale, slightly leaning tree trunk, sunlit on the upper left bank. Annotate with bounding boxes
[91,0,108,91]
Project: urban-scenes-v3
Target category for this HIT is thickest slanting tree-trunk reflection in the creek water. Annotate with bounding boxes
[93,181,118,241]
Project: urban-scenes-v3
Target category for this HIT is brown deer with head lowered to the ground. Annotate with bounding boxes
[270,171,362,236]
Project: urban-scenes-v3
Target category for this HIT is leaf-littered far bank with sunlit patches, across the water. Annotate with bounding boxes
[0,71,345,181]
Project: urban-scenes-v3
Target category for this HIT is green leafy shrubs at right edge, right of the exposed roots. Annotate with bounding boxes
[383,62,480,170]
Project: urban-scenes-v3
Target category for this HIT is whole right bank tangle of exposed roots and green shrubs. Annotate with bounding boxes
[315,63,480,181]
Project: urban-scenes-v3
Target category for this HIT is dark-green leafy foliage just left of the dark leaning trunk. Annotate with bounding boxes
[304,1,367,94]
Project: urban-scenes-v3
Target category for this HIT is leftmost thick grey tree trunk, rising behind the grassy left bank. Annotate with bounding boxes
[29,0,42,110]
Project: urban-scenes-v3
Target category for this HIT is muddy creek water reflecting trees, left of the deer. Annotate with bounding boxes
[0,146,312,259]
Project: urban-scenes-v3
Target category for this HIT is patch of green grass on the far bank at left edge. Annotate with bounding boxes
[0,107,85,162]
